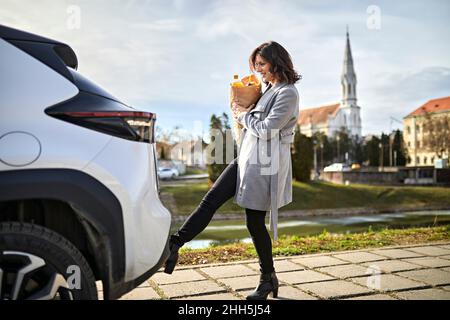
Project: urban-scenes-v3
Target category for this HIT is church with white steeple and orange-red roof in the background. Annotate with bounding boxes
[298,30,361,137]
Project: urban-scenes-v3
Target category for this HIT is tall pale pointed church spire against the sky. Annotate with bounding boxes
[341,25,356,105]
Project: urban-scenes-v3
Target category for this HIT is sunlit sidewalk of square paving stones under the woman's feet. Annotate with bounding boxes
[100,242,450,300]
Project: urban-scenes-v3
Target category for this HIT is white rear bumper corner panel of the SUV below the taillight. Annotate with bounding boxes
[83,138,171,280]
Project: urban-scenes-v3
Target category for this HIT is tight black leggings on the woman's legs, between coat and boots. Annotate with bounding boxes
[172,159,274,273]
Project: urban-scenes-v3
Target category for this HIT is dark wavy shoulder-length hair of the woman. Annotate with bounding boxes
[248,41,302,84]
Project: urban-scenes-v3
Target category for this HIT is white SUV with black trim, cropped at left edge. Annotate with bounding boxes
[0,25,171,299]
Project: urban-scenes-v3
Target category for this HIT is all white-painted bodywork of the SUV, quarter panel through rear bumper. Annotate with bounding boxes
[0,26,171,298]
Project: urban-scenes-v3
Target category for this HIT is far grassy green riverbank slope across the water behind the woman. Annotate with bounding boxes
[161,180,450,221]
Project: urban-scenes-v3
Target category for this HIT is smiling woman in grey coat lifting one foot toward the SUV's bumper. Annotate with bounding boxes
[164,41,301,300]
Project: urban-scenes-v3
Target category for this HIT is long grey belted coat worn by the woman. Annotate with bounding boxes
[234,83,299,240]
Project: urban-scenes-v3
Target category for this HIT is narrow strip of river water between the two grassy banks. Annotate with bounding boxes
[172,210,450,249]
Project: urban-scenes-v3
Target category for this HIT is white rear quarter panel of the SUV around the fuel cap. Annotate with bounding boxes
[0,39,111,170]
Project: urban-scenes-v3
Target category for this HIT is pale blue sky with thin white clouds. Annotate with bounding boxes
[0,0,450,140]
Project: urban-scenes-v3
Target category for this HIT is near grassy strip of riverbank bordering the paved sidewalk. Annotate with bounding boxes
[179,225,450,265]
